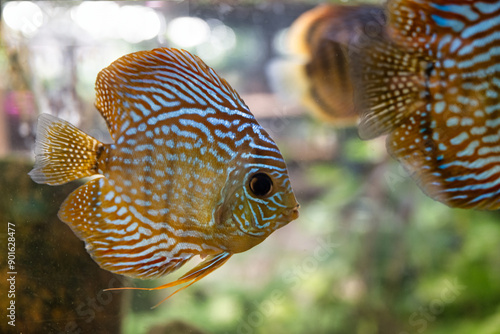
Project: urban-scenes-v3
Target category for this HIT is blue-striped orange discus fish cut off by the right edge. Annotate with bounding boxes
[353,0,500,210]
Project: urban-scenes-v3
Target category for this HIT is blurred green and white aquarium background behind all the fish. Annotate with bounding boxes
[0,1,500,334]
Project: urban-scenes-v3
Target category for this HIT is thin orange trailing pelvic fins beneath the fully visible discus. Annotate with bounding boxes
[107,252,232,308]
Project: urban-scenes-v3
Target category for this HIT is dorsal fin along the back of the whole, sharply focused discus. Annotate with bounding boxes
[96,48,253,139]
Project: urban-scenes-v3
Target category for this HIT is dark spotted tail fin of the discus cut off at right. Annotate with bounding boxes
[353,33,428,139]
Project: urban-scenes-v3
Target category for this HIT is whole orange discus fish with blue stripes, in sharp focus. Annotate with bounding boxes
[29,48,299,298]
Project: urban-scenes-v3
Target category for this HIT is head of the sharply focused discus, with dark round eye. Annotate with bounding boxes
[214,144,299,253]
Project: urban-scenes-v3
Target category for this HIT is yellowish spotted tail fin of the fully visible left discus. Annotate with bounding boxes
[29,114,104,185]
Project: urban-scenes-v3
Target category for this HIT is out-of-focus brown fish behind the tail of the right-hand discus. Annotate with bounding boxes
[288,4,386,127]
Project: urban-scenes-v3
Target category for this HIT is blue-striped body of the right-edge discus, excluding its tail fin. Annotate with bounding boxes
[388,0,500,209]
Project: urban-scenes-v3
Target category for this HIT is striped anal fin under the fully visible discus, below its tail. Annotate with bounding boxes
[58,177,194,278]
